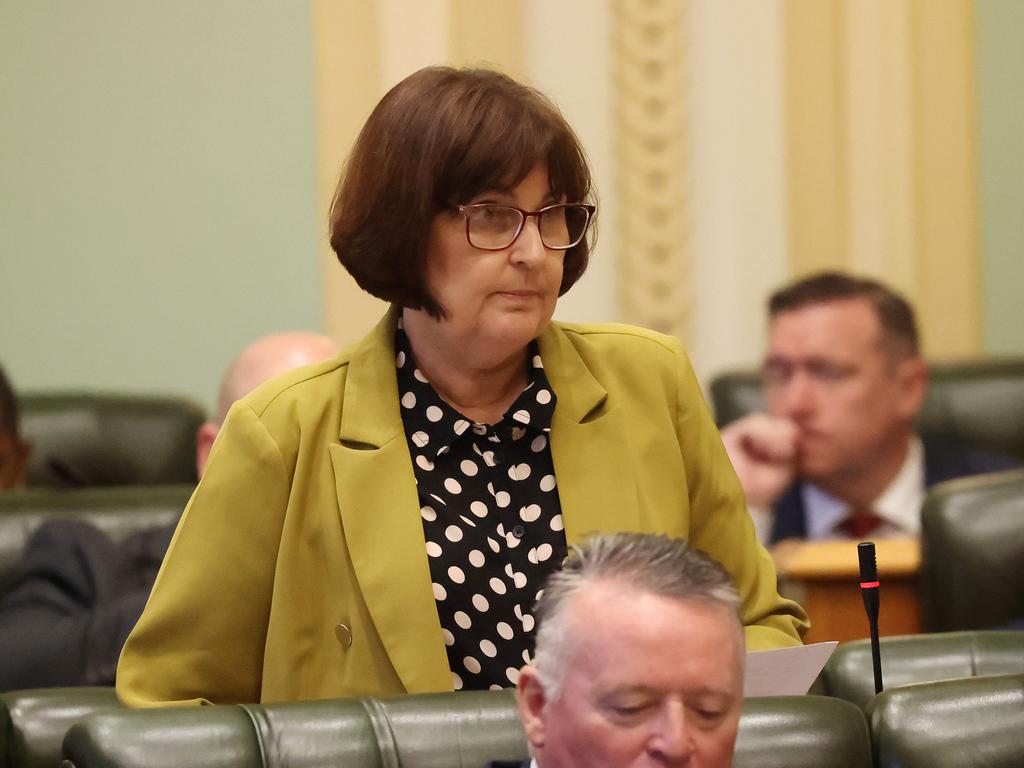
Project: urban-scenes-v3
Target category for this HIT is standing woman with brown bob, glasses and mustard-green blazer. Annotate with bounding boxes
[118,68,806,706]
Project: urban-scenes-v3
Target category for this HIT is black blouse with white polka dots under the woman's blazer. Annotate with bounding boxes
[395,326,566,690]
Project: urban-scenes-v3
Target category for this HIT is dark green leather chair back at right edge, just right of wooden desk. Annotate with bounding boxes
[921,470,1024,632]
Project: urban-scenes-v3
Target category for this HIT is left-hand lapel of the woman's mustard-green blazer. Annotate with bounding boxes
[331,310,452,693]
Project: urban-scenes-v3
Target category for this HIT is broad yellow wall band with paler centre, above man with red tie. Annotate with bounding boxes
[785,0,981,357]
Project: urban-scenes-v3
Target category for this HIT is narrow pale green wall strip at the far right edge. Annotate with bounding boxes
[977,0,1024,354]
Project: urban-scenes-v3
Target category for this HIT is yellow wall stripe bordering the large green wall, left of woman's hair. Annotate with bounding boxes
[312,0,384,343]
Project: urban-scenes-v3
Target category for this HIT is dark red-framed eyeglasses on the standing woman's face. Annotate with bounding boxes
[458,203,597,251]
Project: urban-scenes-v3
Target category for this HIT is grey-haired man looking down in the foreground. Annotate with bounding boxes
[501,534,744,768]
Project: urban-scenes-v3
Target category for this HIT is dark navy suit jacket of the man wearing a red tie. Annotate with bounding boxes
[771,435,1020,544]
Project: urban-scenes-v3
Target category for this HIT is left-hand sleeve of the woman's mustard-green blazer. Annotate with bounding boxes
[117,402,290,707]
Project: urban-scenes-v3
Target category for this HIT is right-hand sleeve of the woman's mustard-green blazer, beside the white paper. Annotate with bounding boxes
[673,342,810,650]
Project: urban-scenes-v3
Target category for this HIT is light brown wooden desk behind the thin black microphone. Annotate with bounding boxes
[772,539,921,643]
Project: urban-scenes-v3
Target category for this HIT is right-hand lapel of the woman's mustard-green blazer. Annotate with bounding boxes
[539,323,640,542]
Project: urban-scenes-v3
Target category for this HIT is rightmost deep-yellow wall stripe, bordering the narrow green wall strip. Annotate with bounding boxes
[910,0,981,357]
